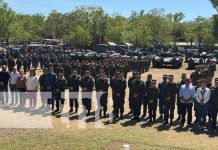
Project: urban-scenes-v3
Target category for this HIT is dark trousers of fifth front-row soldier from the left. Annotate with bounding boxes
[113,94,125,115]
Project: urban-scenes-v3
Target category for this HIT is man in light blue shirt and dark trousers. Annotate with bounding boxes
[179,78,195,126]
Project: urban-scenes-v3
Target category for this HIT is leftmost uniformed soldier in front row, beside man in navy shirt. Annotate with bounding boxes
[54,72,67,112]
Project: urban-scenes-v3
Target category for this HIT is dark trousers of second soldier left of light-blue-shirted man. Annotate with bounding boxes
[164,98,175,120]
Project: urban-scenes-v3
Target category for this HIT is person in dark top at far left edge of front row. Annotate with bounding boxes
[0,65,10,104]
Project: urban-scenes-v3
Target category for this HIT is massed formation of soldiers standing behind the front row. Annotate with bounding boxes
[0,52,151,78]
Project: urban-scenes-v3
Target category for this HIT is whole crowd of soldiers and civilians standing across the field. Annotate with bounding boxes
[0,49,218,128]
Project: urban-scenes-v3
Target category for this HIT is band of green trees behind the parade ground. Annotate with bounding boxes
[0,0,218,48]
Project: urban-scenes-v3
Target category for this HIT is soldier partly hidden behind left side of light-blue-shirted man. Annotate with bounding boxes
[177,74,186,121]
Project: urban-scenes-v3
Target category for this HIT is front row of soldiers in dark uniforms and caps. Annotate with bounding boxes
[40,69,218,129]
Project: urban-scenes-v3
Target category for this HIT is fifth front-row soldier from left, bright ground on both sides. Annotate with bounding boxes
[113,73,126,119]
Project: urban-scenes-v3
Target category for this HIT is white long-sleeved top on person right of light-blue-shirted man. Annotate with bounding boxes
[196,87,210,104]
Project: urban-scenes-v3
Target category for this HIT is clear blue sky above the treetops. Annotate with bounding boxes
[4,0,216,20]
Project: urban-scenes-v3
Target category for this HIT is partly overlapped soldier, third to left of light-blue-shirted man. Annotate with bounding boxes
[158,75,168,119]
